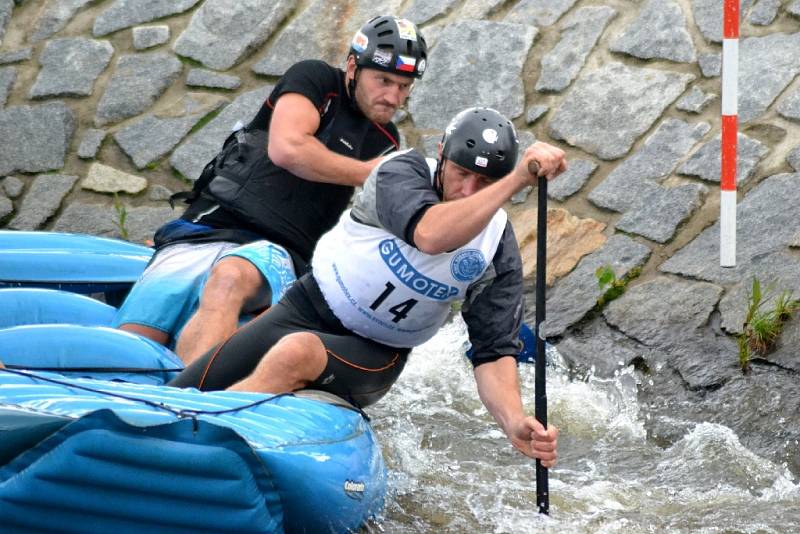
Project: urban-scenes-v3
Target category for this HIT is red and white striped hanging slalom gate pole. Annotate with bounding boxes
[719,0,739,267]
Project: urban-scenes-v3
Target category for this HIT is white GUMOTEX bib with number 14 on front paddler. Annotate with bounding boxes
[312,210,508,347]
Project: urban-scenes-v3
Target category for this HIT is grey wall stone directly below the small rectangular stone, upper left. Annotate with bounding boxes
[94,52,183,126]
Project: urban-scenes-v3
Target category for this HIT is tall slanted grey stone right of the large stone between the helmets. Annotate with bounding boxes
[536,6,617,92]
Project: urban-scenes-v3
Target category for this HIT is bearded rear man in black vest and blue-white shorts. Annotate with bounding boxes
[115,16,427,363]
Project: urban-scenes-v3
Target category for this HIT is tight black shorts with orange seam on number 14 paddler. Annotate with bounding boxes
[168,274,411,407]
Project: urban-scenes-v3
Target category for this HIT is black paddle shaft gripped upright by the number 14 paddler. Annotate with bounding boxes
[528,162,550,514]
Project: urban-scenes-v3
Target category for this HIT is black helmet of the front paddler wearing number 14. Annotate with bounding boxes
[442,108,519,180]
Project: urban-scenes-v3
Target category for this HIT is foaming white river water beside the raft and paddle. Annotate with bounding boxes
[367,319,800,533]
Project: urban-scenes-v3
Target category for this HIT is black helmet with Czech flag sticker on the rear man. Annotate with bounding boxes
[350,16,428,78]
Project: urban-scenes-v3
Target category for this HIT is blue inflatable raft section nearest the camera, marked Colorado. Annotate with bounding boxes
[0,369,386,534]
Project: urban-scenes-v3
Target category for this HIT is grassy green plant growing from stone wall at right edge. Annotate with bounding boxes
[737,277,800,372]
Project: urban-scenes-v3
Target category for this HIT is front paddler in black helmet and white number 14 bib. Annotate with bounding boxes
[171,108,566,466]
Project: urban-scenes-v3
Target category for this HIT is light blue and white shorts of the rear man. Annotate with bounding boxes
[114,240,297,343]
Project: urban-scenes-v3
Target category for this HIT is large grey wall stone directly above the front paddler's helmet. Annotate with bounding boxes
[408,20,536,128]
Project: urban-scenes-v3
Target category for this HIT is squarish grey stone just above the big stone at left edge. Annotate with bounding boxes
[29,37,114,98]
